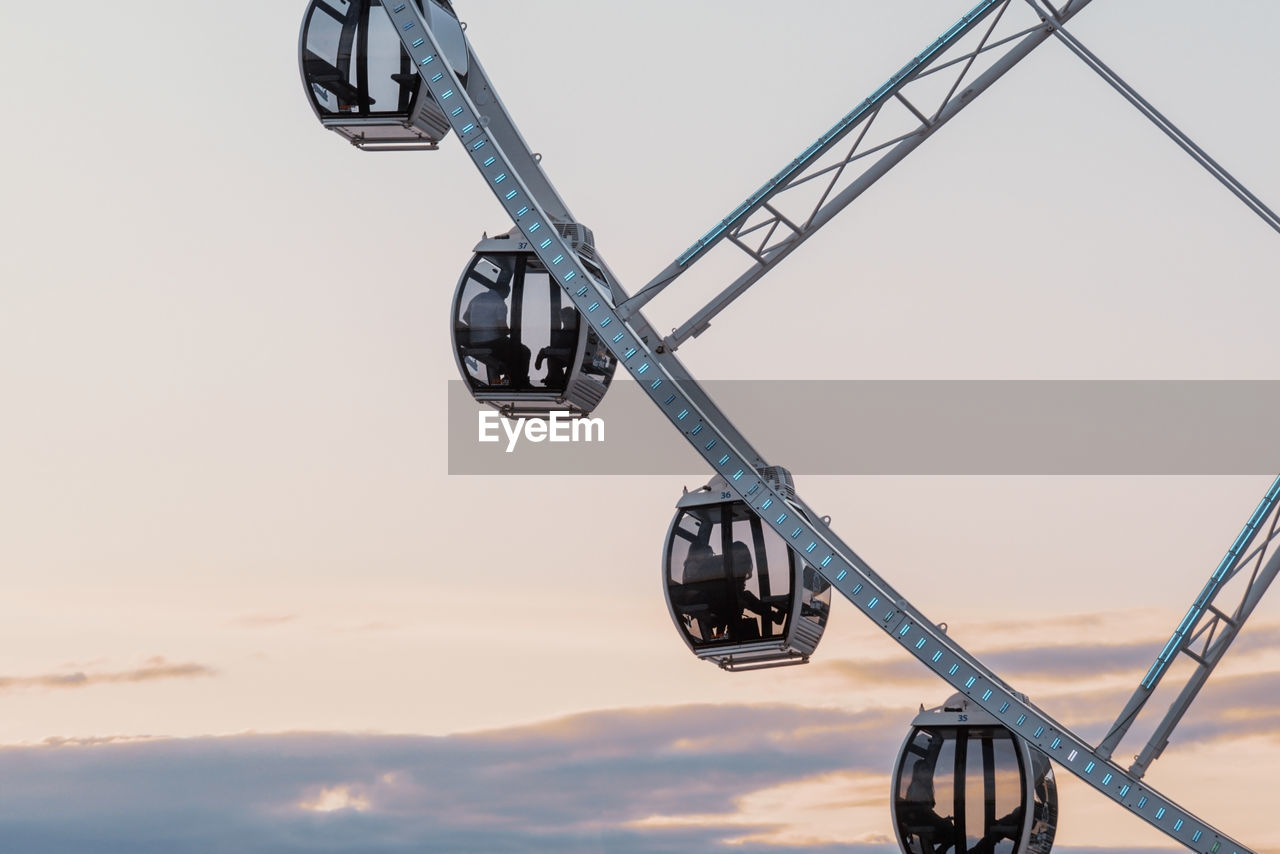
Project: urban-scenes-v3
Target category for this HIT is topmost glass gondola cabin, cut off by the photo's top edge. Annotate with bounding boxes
[298,0,470,151]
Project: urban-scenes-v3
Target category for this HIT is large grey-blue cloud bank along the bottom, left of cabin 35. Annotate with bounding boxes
[0,701,1274,854]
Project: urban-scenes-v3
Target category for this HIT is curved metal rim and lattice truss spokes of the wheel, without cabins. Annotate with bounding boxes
[345,0,1280,854]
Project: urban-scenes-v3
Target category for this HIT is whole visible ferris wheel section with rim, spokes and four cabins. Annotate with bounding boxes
[300,0,1280,854]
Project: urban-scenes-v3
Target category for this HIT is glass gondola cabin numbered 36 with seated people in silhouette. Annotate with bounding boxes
[662,478,831,670]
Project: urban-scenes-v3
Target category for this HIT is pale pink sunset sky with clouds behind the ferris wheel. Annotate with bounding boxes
[0,0,1280,854]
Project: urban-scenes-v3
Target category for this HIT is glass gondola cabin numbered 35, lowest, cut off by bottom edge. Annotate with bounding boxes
[892,694,1057,854]
